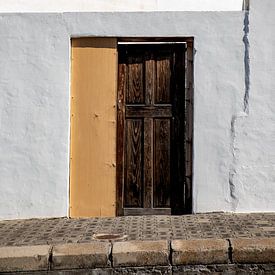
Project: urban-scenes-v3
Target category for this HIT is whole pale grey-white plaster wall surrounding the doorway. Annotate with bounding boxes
[0,0,275,219]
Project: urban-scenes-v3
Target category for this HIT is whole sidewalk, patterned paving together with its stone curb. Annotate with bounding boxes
[0,213,275,274]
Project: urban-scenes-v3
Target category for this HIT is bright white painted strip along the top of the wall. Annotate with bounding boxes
[0,0,243,12]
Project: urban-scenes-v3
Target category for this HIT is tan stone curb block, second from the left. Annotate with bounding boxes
[51,242,111,270]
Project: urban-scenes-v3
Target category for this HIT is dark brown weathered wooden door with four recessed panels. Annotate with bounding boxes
[117,43,191,215]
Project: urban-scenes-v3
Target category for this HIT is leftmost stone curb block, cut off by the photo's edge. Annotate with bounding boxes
[0,245,51,273]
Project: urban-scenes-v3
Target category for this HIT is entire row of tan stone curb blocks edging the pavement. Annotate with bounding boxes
[0,238,275,273]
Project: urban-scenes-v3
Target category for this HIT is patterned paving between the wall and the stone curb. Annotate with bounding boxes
[0,213,275,246]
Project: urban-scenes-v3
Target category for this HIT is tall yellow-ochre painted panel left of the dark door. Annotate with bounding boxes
[70,38,117,217]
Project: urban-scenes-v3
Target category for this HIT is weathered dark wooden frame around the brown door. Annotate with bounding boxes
[116,37,194,216]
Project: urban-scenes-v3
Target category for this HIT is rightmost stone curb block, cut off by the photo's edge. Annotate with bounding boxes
[230,238,275,263]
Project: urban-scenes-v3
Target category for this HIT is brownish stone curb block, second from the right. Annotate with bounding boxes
[172,239,229,265]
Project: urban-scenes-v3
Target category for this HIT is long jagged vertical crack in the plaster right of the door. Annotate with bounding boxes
[228,0,250,211]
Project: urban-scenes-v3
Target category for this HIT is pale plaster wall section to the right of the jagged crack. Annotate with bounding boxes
[233,0,275,211]
